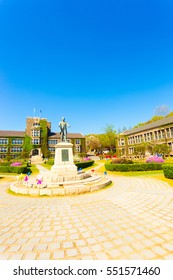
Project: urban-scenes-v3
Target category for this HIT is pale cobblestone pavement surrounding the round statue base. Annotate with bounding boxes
[0,177,173,260]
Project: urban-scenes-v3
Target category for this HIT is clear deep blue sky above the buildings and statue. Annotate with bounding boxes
[0,0,173,134]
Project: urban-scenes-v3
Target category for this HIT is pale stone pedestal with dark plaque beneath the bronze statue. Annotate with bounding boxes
[51,142,77,177]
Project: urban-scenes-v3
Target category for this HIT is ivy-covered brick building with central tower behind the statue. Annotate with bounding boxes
[0,117,86,159]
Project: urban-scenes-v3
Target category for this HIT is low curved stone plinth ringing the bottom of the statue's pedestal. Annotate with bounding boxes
[10,175,111,197]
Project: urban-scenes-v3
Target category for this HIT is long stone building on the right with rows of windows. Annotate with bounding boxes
[117,116,173,157]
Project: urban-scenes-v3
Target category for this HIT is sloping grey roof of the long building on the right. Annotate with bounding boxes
[124,116,173,135]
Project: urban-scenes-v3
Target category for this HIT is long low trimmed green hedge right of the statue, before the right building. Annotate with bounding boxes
[105,162,162,172]
